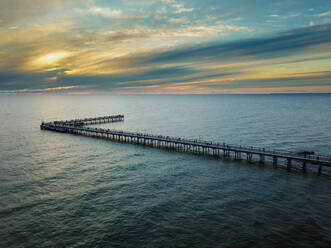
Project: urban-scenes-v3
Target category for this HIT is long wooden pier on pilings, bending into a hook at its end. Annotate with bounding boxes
[40,115,331,174]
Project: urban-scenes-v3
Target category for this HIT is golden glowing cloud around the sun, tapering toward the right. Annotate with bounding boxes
[0,20,249,79]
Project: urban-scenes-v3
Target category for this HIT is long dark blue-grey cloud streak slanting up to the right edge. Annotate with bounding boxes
[146,24,331,63]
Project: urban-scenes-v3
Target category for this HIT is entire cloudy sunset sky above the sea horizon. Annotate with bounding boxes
[0,0,331,95]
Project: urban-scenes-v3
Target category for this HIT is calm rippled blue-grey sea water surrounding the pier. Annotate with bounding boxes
[0,94,331,248]
